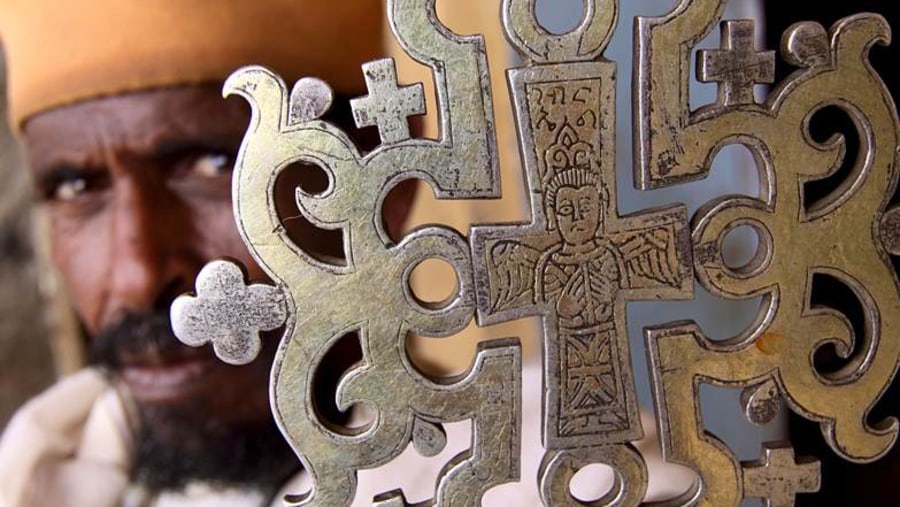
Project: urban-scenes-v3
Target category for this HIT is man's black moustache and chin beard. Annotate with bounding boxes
[91,312,300,497]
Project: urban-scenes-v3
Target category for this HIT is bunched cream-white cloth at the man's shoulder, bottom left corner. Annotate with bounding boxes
[0,370,128,507]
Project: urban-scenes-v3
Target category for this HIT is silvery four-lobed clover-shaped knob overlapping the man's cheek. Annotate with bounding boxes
[170,261,287,365]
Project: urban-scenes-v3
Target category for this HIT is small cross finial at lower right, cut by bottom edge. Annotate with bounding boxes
[744,444,821,507]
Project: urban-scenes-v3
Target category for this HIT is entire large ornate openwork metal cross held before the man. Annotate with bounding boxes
[173,0,900,506]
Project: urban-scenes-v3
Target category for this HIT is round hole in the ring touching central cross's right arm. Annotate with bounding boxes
[720,220,772,278]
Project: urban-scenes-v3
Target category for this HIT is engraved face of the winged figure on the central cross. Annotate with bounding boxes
[556,185,603,245]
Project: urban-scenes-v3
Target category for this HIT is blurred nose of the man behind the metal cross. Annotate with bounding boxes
[104,171,201,322]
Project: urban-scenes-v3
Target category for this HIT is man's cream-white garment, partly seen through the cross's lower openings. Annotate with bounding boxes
[0,364,693,507]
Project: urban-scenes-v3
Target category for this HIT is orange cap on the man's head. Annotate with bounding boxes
[0,0,384,127]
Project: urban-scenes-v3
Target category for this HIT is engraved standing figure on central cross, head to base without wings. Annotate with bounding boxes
[536,168,628,435]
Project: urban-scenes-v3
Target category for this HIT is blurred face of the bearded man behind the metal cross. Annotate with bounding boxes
[24,86,296,492]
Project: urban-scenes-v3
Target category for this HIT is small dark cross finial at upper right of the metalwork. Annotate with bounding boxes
[697,19,775,106]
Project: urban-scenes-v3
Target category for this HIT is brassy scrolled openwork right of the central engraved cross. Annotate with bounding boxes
[637,1,900,505]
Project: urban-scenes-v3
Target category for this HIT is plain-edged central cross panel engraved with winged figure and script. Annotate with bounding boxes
[472,64,691,449]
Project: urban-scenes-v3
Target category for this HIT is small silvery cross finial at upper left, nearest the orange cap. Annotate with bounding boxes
[350,58,425,144]
